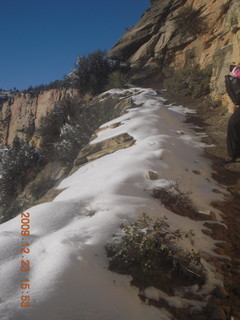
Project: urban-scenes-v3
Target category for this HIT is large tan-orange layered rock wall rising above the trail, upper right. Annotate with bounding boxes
[108,0,240,107]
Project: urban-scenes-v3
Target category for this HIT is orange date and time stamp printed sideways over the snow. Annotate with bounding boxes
[20,212,31,308]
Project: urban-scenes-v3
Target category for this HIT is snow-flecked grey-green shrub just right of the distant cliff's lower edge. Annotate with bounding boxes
[39,97,92,164]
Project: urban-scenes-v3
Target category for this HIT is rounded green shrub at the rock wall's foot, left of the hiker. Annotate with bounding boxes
[164,63,212,98]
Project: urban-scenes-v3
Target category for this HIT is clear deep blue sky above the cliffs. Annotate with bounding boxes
[0,0,150,90]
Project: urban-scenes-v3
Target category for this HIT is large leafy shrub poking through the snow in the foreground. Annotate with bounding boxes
[106,214,204,287]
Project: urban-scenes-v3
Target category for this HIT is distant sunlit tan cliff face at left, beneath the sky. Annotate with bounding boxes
[0,89,76,145]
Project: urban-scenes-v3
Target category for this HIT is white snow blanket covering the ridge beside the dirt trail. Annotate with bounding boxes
[0,88,225,320]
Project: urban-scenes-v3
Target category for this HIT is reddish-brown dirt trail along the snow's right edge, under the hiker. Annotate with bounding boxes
[160,93,240,320]
